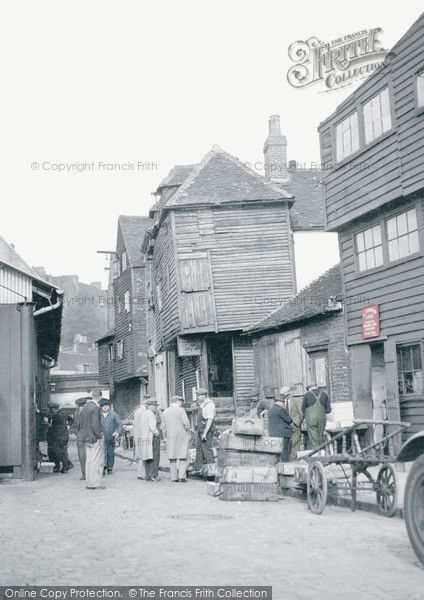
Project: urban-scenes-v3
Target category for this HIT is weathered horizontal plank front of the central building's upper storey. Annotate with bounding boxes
[174,204,295,332]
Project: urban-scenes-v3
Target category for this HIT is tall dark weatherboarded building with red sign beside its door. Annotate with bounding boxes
[319,15,424,434]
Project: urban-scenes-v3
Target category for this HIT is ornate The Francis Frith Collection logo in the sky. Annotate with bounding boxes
[287,28,387,92]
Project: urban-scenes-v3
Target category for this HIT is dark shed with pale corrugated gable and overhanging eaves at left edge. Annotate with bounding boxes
[0,237,63,479]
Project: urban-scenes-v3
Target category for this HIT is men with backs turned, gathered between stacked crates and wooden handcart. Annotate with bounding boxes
[251,383,331,462]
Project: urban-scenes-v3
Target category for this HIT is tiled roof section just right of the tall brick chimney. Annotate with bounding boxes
[280,168,325,231]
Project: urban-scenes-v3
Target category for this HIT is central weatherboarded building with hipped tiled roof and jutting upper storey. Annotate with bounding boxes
[143,116,323,422]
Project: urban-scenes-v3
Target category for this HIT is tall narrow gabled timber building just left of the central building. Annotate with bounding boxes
[97,216,151,417]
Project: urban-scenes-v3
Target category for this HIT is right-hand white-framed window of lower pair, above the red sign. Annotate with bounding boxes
[387,208,420,261]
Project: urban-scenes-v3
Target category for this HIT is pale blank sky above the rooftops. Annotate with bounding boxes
[0,0,422,288]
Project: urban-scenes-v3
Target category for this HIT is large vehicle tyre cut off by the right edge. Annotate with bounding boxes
[404,454,424,564]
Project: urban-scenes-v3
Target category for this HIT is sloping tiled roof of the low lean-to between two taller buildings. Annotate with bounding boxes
[246,263,342,333]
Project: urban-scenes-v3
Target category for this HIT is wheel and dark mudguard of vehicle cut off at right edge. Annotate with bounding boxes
[397,431,424,564]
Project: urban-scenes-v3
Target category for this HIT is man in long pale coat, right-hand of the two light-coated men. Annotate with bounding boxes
[163,396,191,483]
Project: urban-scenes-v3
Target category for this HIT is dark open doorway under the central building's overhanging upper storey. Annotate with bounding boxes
[207,334,233,397]
